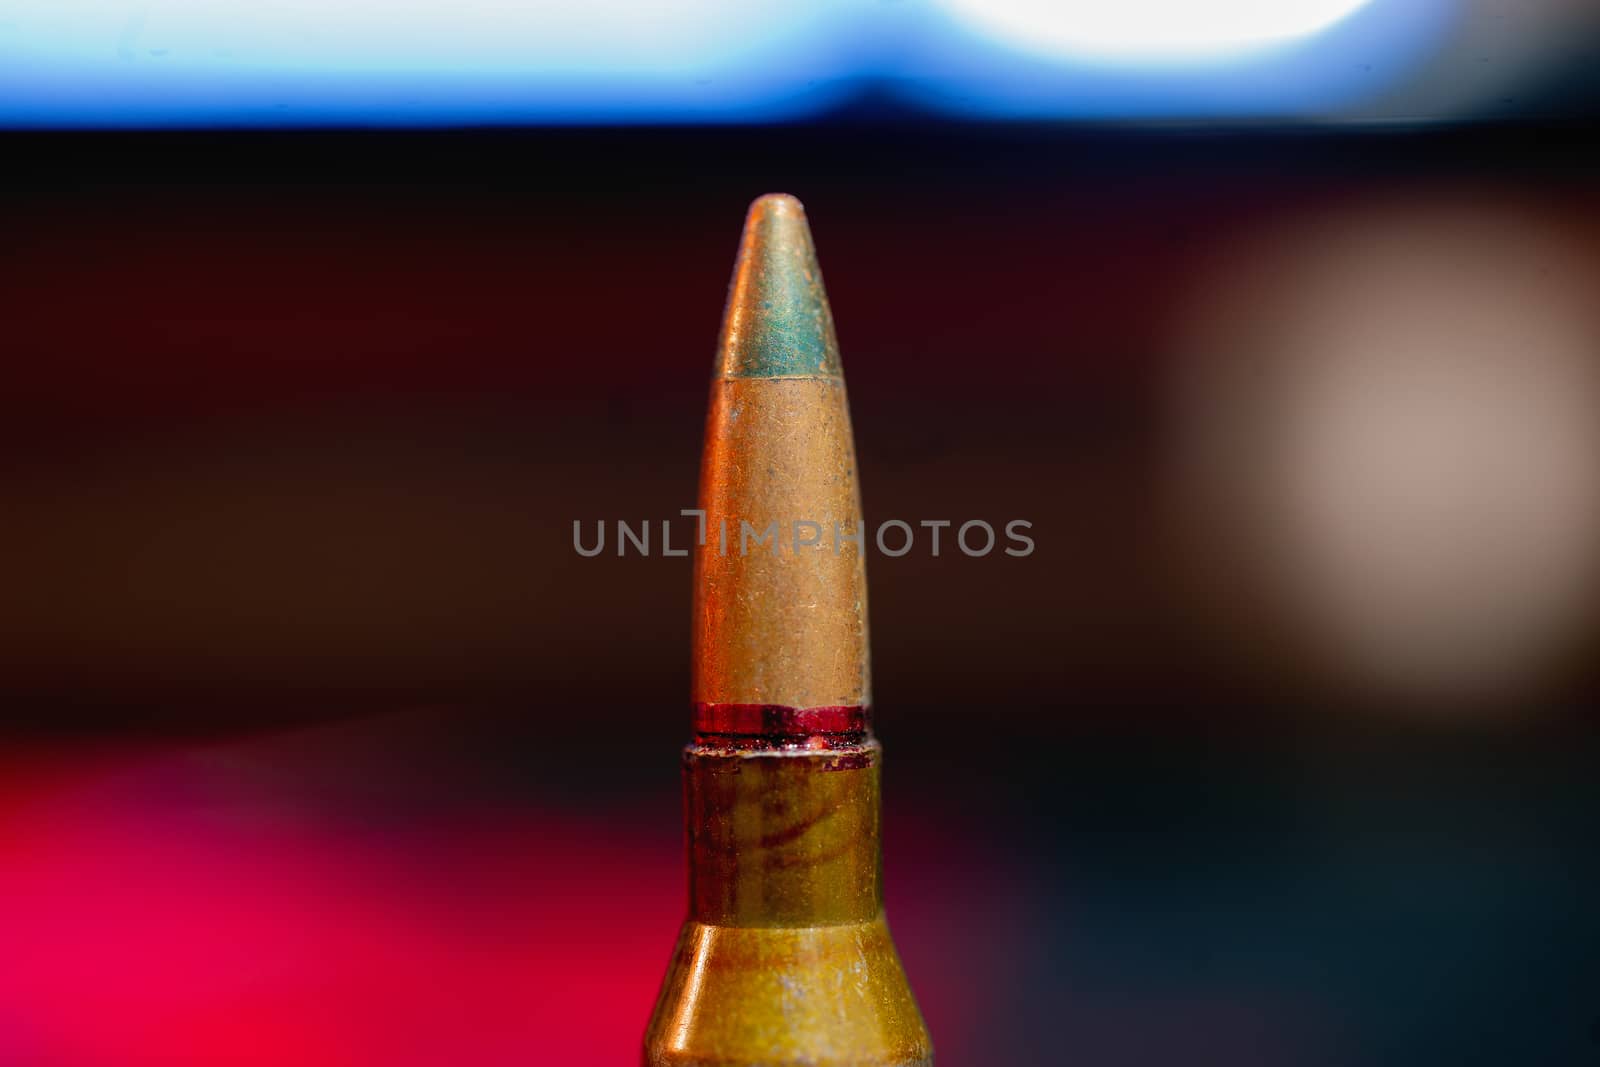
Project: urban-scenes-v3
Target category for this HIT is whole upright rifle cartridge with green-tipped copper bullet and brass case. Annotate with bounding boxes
[643,195,933,1067]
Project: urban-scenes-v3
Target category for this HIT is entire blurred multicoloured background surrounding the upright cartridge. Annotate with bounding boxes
[0,0,1600,1067]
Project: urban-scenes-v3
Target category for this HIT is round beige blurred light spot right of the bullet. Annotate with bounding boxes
[1179,198,1600,704]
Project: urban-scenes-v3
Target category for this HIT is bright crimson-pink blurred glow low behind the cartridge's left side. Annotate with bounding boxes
[0,742,1005,1067]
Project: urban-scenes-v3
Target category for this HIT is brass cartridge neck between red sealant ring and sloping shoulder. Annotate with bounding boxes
[683,735,883,926]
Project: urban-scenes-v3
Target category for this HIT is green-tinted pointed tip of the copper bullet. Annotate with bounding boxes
[715,194,840,378]
